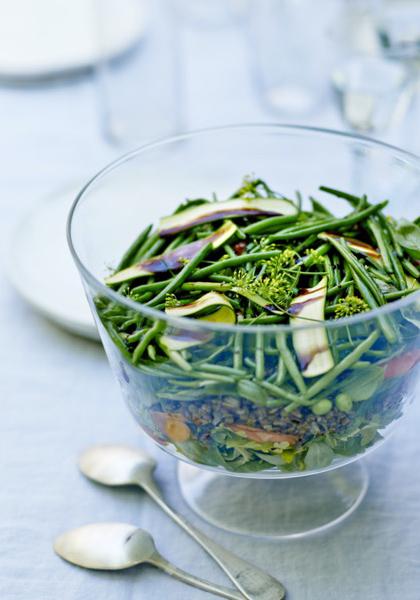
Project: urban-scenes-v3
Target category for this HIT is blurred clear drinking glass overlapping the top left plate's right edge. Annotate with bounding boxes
[93,0,184,149]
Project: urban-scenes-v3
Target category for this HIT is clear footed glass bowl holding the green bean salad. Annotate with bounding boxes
[68,125,420,537]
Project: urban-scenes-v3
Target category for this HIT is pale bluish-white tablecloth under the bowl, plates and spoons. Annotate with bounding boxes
[0,10,420,600]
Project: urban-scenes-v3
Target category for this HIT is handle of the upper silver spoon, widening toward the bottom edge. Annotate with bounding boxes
[141,479,286,600]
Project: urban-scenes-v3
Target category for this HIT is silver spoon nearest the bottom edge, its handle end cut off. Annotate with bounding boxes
[54,523,243,600]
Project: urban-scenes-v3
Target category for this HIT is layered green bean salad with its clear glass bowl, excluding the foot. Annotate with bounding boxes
[69,125,420,536]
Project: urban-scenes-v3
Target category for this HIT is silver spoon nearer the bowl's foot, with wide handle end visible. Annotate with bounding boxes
[79,446,286,600]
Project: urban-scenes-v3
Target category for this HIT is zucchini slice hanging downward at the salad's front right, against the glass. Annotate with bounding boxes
[288,277,334,377]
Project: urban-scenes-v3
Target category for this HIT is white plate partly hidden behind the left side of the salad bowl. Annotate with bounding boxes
[7,181,99,340]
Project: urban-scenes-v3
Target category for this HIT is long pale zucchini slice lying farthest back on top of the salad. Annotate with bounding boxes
[158,198,298,237]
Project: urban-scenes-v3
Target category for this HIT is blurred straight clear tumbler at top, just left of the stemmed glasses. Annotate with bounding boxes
[245,0,337,117]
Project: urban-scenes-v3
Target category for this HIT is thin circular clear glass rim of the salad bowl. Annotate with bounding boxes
[66,123,420,334]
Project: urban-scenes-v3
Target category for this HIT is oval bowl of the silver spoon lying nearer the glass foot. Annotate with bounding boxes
[79,445,156,486]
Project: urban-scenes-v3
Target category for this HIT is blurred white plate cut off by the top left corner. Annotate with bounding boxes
[0,0,146,79]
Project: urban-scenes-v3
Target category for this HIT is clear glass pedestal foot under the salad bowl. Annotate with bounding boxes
[178,461,369,539]
